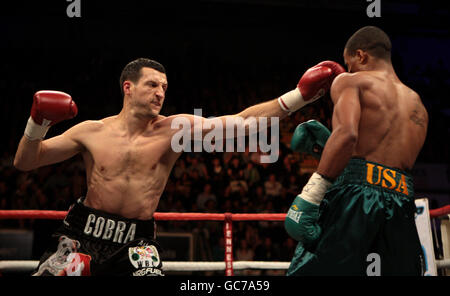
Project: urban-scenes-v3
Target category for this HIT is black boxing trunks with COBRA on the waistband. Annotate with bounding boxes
[33,198,163,276]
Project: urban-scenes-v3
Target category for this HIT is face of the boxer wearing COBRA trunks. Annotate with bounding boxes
[129,68,167,117]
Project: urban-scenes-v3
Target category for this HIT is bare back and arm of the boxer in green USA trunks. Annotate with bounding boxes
[318,51,428,178]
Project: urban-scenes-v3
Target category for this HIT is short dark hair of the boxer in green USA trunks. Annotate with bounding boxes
[345,26,392,60]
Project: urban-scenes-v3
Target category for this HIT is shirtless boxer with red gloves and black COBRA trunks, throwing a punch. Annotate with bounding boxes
[14,58,348,275]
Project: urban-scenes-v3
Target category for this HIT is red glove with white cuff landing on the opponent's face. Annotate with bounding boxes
[278,61,345,112]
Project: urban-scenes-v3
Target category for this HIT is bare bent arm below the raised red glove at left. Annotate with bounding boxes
[14,124,83,171]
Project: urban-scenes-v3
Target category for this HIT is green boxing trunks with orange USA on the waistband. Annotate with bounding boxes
[287,158,424,276]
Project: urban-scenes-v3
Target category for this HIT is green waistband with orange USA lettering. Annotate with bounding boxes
[334,158,414,196]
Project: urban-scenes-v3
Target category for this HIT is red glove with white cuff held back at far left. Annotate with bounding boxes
[25,90,78,140]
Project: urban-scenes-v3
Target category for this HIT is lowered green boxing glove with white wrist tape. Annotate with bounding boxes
[284,173,332,244]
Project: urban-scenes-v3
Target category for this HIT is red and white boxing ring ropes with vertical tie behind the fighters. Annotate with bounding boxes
[0,205,450,276]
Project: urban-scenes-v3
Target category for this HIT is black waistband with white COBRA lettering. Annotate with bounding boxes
[63,197,155,244]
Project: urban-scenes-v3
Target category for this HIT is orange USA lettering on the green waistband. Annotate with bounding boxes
[366,163,409,195]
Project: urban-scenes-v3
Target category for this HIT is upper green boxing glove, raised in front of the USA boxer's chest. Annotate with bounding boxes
[291,119,331,159]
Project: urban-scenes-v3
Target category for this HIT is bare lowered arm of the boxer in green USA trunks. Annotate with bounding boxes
[317,74,361,179]
